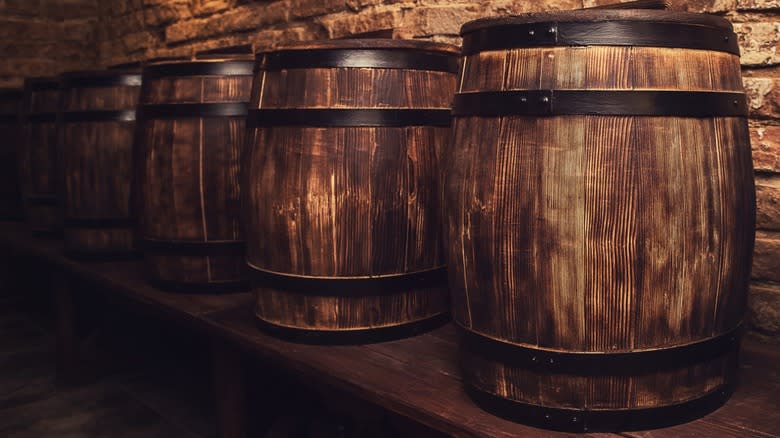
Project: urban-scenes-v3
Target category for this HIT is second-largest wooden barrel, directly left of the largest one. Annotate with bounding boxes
[242,39,458,343]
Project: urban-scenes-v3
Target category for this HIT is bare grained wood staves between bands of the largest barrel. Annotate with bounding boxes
[445,41,755,409]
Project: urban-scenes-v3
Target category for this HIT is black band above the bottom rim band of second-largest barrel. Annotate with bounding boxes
[248,265,447,297]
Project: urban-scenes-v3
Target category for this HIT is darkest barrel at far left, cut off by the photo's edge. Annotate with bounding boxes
[0,88,24,221]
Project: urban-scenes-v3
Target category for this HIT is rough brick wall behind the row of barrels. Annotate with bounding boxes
[0,0,780,342]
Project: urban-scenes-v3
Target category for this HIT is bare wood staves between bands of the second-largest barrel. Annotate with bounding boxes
[244,40,455,331]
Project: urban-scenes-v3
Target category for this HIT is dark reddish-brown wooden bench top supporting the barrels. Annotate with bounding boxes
[0,223,780,438]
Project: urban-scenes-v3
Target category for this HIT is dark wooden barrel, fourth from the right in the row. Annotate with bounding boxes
[58,70,141,259]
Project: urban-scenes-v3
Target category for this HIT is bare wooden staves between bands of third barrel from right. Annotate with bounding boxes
[137,61,252,290]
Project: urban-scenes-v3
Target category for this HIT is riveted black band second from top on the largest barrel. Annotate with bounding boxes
[453,90,748,117]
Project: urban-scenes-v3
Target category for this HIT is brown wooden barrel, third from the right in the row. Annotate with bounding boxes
[136,57,254,292]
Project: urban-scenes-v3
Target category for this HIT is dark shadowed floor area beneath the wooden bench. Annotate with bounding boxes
[0,265,441,438]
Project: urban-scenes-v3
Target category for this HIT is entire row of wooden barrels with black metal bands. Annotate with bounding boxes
[0,11,754,430]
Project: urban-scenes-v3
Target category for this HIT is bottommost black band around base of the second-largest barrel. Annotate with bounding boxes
[255,313,450,345]
